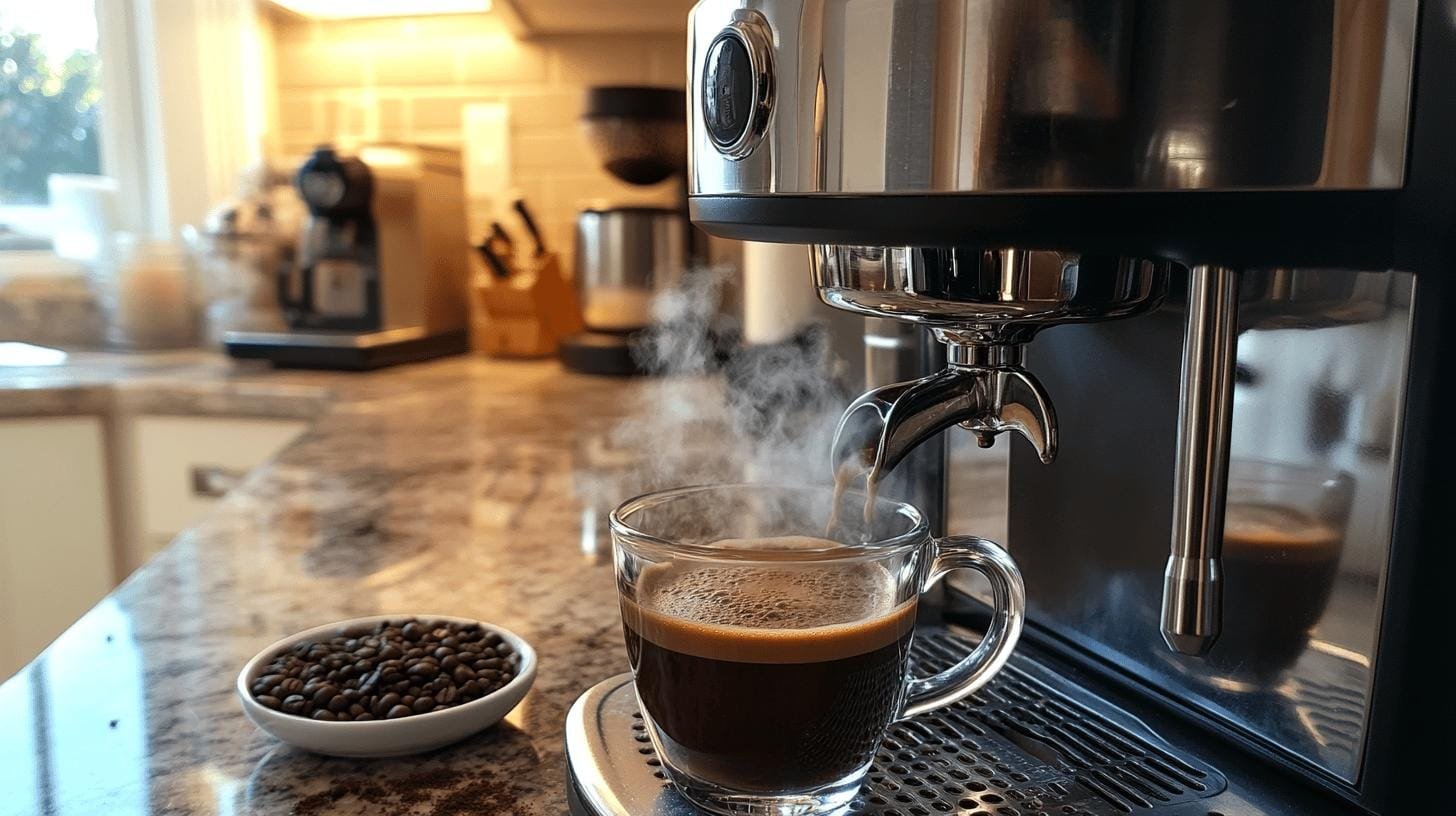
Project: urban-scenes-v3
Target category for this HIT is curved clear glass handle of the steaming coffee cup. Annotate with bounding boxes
[900,536,1026,718]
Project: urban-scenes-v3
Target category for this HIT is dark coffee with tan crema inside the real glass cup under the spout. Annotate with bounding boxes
[622,550,914,793]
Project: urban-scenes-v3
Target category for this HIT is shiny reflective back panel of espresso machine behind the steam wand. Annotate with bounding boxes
[1001,270,1414,781]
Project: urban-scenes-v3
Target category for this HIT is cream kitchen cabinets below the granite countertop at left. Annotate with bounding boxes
[0,414,307,680]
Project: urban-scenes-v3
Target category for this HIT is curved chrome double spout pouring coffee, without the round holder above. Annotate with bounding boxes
[834,338,1057,482]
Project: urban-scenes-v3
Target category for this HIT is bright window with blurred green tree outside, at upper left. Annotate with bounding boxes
[0,0,103,249]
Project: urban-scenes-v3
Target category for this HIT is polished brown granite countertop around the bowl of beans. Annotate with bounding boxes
[0,353,722,816]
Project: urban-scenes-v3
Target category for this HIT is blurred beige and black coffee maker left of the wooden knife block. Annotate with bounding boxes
[224,144,470,369]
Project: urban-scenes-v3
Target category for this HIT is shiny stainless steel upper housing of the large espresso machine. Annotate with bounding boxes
[689,0,1417,195]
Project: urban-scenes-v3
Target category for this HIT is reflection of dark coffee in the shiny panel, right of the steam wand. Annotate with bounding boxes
[1208,504,1342,682]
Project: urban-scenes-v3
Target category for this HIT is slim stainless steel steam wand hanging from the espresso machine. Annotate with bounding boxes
[1162,267,1239,654]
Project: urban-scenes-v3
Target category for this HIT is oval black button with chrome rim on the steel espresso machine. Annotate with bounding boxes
[699,12,773,159]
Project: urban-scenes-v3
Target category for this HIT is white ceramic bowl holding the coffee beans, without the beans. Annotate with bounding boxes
[237,615,536,756]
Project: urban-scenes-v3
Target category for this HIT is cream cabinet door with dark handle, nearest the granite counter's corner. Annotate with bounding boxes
[122,417,307,571]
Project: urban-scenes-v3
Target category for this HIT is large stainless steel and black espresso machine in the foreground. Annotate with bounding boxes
[568,0,1456,816]
